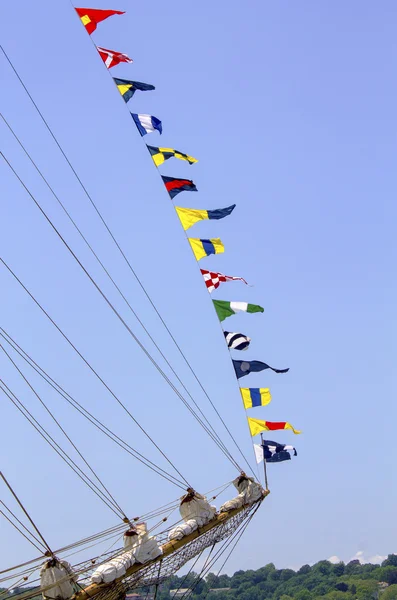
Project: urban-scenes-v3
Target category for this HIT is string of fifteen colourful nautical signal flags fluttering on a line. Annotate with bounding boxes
[75,8,301,472]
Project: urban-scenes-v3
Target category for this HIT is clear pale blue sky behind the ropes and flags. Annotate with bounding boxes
[0,0,397,572]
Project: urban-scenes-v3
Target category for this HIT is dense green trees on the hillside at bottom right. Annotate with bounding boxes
[152,554,397,600]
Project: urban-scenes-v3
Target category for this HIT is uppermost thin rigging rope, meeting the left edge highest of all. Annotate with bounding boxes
[0,40,255,477]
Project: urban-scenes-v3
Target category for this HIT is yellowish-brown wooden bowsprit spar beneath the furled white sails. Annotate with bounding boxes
[71,502,267,600]
